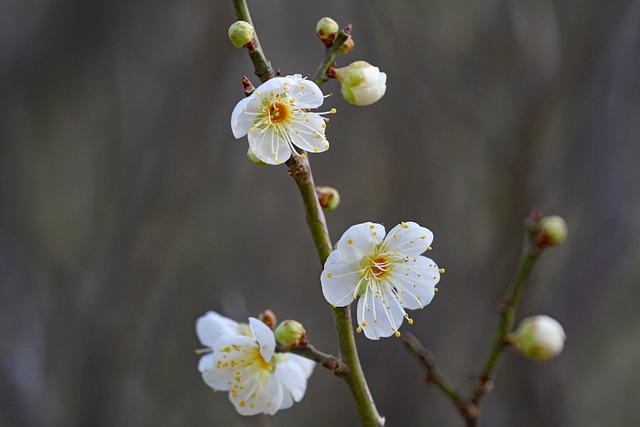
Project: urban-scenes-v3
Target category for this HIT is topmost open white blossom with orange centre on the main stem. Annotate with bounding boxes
[231,74,335,165]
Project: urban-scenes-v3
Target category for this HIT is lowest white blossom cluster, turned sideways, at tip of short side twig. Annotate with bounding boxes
[196,311,315,415]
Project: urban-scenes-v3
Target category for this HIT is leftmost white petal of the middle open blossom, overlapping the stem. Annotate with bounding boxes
[320,249,362,307]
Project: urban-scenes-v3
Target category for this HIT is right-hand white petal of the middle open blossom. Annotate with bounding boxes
[389,256,440,310]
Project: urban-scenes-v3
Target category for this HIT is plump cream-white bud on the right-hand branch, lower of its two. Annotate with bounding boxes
[507,315,567,361]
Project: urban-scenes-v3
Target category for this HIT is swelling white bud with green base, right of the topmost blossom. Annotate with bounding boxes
[335,61,387,105]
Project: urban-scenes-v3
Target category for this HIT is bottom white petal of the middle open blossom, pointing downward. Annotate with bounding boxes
[358,287,404,340]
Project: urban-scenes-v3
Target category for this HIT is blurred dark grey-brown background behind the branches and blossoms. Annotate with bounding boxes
[0,0,640,427]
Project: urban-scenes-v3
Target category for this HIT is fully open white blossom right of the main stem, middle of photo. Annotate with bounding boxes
[320,222,444,340]
